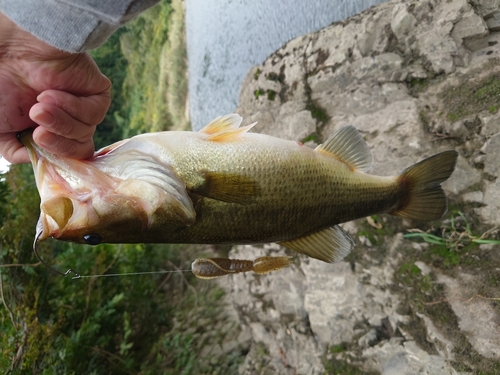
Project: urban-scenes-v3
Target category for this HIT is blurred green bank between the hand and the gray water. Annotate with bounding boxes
[90,0,189,148]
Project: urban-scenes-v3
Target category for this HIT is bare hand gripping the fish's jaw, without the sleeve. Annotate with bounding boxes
[0,13,111,163]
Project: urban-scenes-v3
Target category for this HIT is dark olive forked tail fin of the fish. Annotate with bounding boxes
[390,150,458,220]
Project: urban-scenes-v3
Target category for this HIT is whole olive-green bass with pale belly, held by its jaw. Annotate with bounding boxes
[19,114,457,268]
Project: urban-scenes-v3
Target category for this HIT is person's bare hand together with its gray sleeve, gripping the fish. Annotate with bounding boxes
[0,0,157,163]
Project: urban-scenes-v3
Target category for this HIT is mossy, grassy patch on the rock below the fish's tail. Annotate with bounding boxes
[392,207,500,374]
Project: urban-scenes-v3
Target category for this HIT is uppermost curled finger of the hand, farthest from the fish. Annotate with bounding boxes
[37,90,111,125]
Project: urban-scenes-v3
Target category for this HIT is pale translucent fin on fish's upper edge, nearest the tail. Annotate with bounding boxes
[315,125,373,172]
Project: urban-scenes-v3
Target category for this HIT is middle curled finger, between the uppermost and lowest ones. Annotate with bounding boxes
[29,103,95,142]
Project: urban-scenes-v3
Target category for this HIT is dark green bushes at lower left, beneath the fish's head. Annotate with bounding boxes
[0,165,243,374]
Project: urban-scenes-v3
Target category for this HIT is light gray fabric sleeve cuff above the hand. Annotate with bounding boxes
[0,0,159,52]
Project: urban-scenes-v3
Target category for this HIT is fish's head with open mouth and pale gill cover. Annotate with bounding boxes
[19,131,196,245]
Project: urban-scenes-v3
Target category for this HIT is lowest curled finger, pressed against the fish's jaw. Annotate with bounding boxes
[33,126,94,159]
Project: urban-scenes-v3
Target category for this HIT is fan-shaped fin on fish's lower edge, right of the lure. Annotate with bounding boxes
[279,225,354,263]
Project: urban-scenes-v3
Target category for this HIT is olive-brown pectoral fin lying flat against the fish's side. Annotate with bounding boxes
[191,172,260,205]
